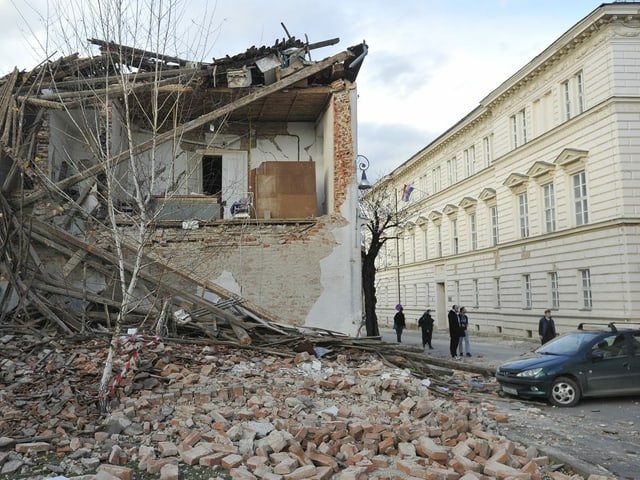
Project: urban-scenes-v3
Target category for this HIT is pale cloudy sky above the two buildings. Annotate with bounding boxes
[0,0,602,179]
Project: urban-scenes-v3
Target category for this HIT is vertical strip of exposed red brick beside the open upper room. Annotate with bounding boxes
[331,80,356,213]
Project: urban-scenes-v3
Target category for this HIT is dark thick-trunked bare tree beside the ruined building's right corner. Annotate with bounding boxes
[360,182,408,336]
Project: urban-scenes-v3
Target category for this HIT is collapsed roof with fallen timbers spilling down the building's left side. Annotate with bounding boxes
[0,34,367,341]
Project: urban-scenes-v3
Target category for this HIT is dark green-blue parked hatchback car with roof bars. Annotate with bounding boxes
[496,323,640,407]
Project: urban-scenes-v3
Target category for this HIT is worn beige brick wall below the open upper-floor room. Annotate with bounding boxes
[151,216,344,325]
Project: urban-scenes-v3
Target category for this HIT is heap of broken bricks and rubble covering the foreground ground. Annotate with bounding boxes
[0,335,616,480]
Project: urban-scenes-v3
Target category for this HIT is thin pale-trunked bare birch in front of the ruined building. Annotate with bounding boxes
[14,0,220,408]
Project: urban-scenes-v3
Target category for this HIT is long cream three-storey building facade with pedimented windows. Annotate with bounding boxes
[377,3,640,339]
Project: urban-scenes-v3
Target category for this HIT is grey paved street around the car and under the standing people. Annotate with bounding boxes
[381,328,640,480]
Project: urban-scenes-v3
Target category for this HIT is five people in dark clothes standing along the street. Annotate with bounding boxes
[393,304,557,359]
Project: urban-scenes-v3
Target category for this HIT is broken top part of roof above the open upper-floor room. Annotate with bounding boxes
[0,37,367,132]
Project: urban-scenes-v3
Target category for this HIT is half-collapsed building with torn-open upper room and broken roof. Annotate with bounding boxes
[0,33,367,333]
